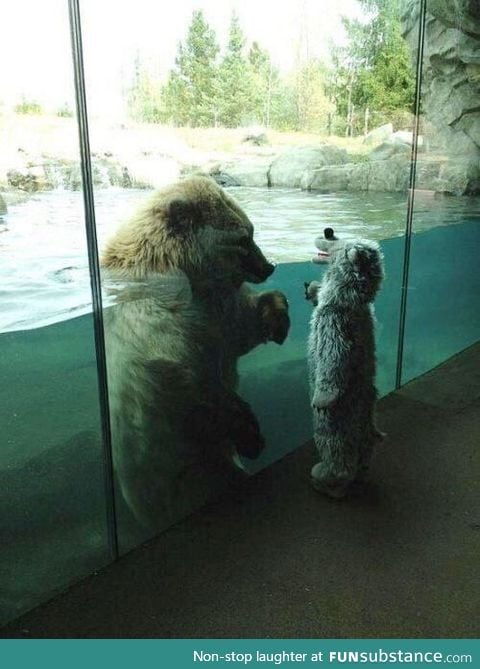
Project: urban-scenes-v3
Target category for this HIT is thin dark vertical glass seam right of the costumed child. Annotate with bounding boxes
[395,0,427,390]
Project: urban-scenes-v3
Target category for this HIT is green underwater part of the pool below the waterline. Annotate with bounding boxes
[0,221,480,621]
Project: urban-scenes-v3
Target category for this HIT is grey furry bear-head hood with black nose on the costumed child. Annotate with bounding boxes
[313,228,384,304]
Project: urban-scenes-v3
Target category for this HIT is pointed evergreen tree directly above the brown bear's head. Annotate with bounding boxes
[164,10,219,127]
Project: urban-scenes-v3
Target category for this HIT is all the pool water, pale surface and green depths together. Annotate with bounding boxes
[0,189,480,622]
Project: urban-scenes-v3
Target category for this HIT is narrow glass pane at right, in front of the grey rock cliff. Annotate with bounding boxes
[402,1,480,383]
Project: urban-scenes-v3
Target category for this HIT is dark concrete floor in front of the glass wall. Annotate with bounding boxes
[0,346,480,638]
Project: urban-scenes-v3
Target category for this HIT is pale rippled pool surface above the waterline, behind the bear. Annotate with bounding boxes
[0,188,480,331]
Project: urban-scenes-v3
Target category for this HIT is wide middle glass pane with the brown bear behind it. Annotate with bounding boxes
[82,2,415,551]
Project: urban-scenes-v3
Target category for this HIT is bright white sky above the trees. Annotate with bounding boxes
[0,0,361,116]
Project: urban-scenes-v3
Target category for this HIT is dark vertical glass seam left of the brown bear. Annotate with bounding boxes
[68,0,118,560]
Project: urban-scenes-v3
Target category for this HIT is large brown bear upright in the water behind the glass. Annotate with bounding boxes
[102,177,289,531]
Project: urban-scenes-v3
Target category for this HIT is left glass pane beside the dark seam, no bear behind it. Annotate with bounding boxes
[0,1,110,622]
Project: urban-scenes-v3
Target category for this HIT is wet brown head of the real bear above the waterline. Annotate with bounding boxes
[102,176,274,286]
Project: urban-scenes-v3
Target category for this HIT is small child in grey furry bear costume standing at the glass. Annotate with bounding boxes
[305,228,383,498]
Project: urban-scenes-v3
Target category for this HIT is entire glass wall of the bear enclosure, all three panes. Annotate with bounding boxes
[0,0,480,620]
